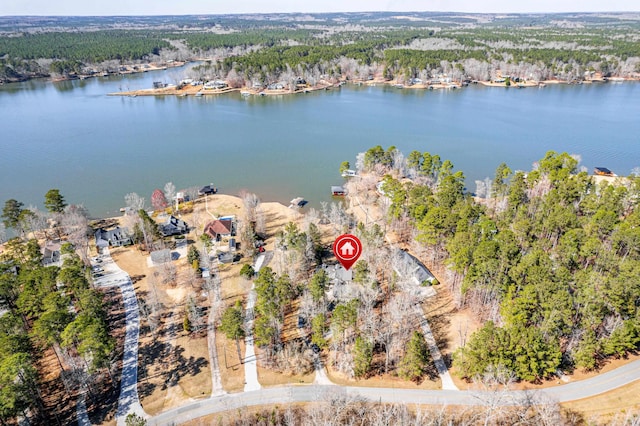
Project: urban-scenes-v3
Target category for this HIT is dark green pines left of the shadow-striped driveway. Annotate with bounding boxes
[0,239,115,424]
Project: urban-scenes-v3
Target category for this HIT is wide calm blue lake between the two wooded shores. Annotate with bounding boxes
[0,65,640,220]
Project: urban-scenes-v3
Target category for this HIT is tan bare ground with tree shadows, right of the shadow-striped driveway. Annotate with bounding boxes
[112,235,211,414]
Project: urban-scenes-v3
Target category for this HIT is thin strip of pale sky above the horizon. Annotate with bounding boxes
[0,0,640,16]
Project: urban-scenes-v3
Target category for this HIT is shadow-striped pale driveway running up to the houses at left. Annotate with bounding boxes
[93,249,148,426]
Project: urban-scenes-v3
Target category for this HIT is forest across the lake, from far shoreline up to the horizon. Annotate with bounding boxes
[0,13,640,82]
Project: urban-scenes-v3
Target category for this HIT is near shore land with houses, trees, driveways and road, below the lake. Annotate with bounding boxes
[0,146,640,424]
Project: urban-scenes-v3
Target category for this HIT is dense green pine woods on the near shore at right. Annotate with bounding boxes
[372,147,640,381]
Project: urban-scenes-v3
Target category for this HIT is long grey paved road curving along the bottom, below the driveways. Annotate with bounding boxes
[148,361,640,425]
